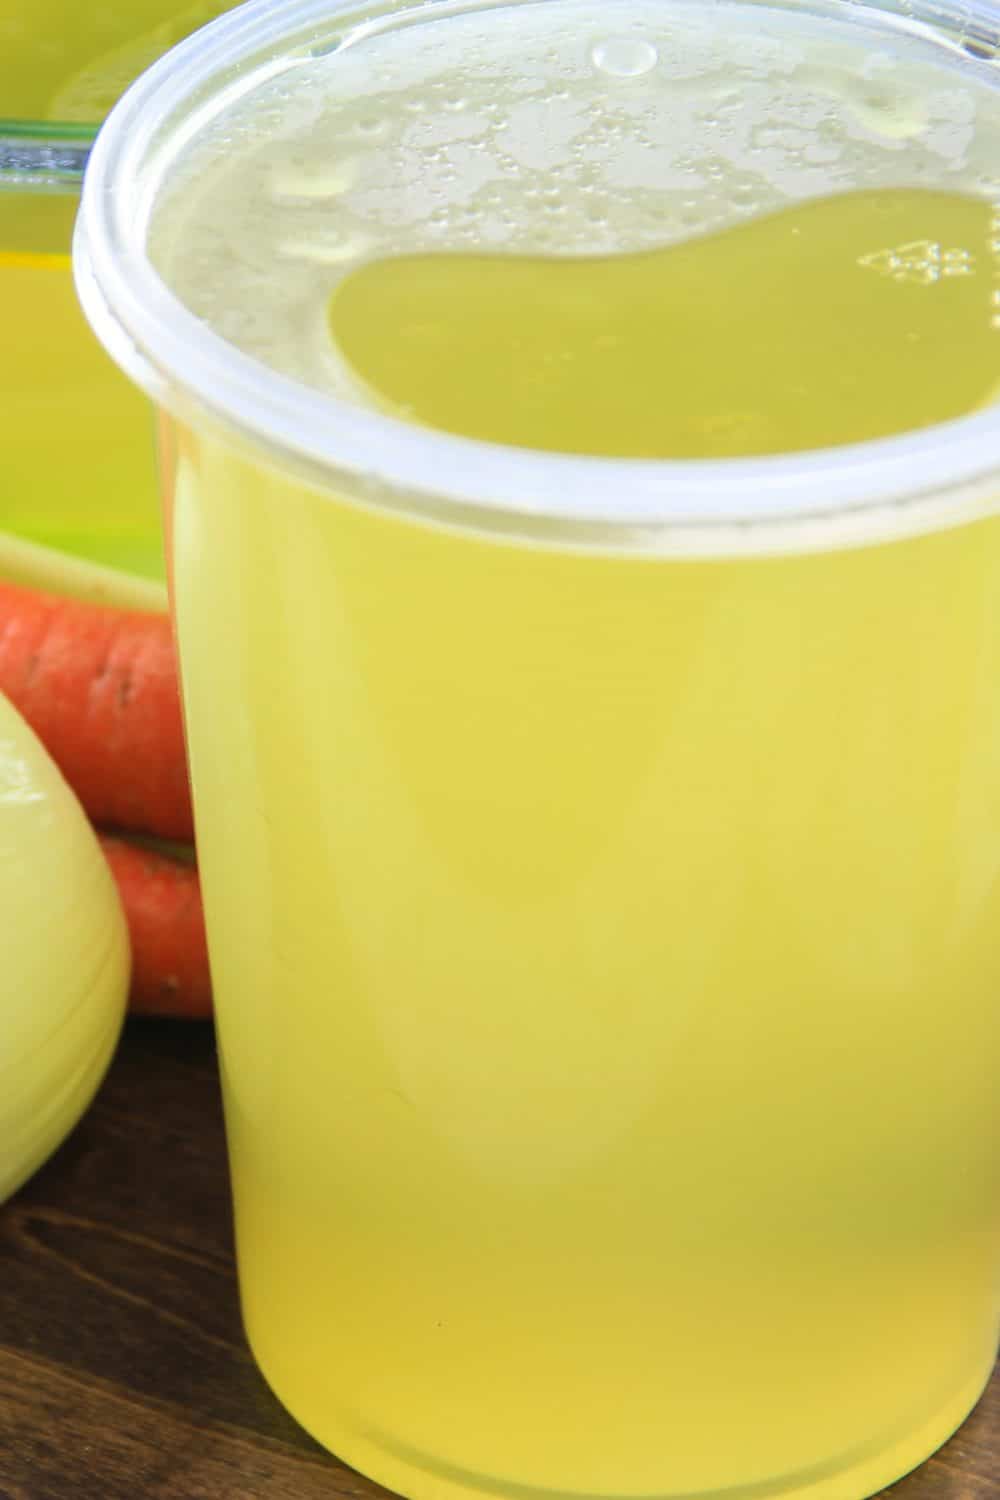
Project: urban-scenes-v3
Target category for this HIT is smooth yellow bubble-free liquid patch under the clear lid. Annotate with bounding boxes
[330,189,1000,458]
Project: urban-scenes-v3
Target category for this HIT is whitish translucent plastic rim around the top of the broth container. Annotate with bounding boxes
[73,0,1000,551]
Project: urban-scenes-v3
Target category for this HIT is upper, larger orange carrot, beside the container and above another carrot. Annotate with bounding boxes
[0,584,193,840]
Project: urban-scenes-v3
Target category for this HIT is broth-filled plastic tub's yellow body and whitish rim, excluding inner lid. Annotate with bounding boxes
[75,0,1000,1500]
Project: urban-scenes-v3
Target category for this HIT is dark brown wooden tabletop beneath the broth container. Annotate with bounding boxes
[0,1022,1000,1500]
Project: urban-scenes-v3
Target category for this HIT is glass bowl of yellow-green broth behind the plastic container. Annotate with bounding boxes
[0,0,242,605]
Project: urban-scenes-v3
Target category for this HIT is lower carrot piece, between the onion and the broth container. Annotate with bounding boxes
[99,834,211,1020]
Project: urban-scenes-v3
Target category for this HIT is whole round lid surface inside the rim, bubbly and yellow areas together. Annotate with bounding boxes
[150,0,1000,458]
